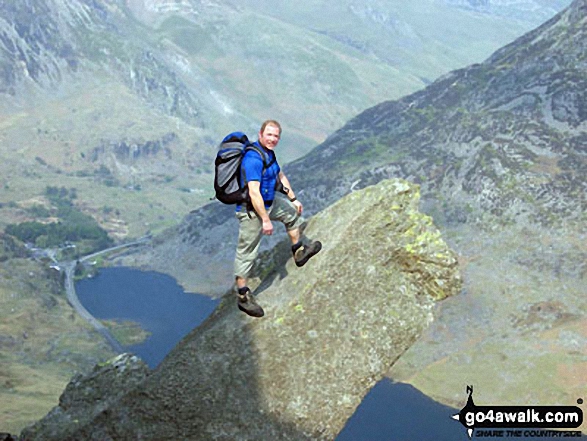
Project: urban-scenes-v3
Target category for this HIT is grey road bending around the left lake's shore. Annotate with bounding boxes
[60,236,150,354]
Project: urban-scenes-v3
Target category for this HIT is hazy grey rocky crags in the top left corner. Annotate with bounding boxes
[0,0,207,125]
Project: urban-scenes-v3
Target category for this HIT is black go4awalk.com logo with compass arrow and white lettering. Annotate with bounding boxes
[453,386,583,439]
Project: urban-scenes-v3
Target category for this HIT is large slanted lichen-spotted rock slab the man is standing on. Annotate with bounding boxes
[20,180,461,441]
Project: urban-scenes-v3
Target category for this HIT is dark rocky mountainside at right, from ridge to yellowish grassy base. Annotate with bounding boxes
[121,0,587,420]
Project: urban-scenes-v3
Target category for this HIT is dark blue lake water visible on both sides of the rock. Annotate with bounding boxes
[76,268,584,441]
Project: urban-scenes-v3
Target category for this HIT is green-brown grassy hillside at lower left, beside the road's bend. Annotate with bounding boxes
[0,259,112,434]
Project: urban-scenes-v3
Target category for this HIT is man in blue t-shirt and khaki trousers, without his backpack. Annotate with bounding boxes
[234,120,322,317]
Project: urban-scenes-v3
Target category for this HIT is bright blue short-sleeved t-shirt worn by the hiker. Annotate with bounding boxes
[236,141,281,211]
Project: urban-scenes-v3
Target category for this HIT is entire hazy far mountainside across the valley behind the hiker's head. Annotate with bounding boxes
[0,0,572,238]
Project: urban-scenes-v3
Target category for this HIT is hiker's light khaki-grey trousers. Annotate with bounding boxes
[234,194,304,279]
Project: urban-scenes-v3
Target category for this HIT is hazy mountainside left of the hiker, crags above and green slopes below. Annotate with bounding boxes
[0,0,223,238]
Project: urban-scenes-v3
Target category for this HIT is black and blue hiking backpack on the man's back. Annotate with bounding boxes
[214,132,275,204]
